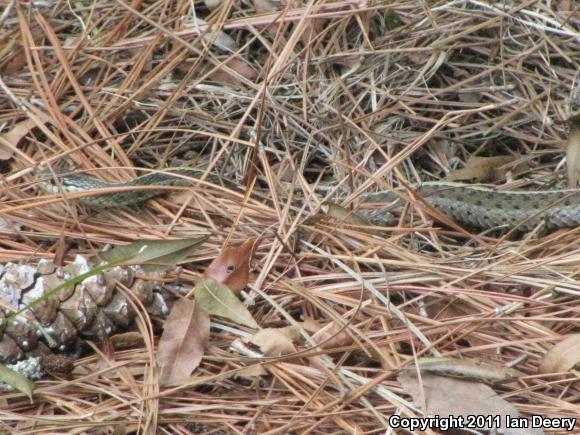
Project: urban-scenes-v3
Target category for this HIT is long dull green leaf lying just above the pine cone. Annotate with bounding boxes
[99,235,209,272]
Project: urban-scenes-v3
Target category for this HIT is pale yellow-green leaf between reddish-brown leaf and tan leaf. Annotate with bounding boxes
[195,278,259,329]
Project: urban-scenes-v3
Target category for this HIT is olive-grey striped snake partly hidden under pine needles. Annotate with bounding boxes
[39,168,580,231]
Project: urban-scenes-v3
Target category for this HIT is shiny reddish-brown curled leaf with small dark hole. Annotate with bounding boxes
[203,239,260,294]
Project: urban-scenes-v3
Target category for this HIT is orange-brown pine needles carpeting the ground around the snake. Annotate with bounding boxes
[0,0,580,434]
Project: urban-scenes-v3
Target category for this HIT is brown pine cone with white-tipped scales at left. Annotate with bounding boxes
[0,255,167,363]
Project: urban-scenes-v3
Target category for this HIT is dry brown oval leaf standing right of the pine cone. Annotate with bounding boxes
[157,299,210,384]
